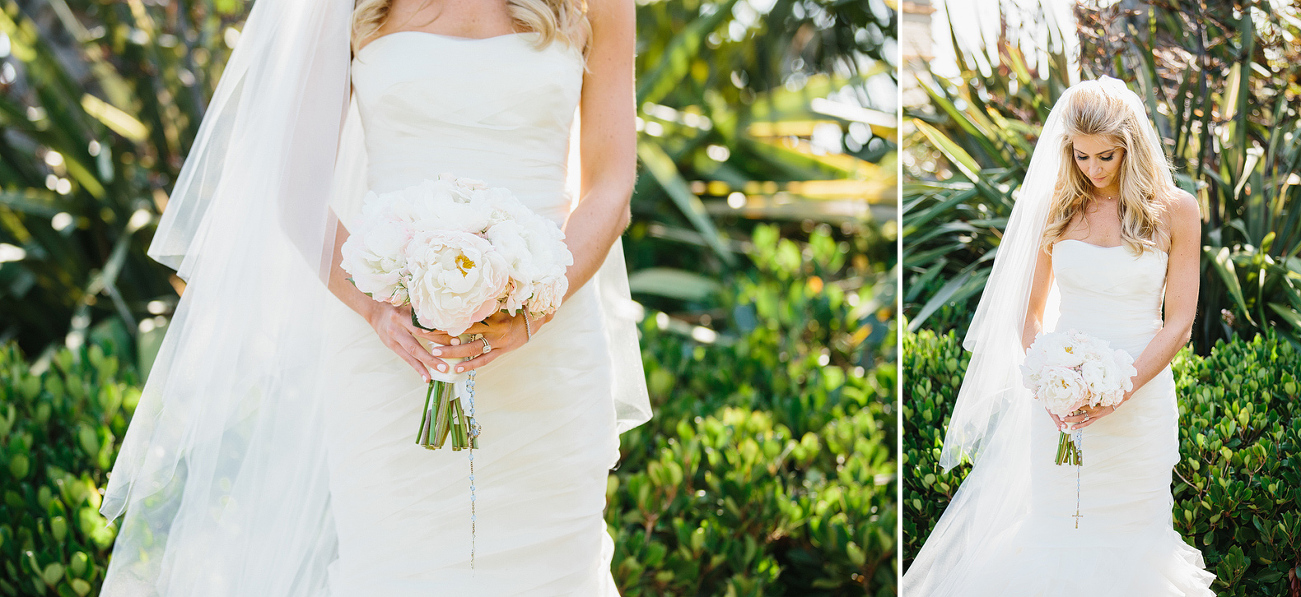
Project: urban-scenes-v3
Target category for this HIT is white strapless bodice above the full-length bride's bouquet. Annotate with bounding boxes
[1053,239,1168,358]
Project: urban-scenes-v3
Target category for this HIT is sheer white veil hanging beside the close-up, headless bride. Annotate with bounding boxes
[100,0,651,596]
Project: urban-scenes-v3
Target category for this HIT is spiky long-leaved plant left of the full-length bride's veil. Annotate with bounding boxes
[900,6,1069,330]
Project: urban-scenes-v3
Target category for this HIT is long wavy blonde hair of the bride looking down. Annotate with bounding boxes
[1043,81,1171,255]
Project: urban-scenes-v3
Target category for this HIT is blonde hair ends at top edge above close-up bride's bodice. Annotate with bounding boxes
[353,0,592,57]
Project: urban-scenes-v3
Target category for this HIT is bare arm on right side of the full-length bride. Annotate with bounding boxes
[1125,191,1202,401]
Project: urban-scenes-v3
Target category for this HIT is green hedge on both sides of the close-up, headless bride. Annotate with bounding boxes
[0,228,898,597]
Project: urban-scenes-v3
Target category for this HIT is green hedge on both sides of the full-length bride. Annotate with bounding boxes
[903,330,1301,597]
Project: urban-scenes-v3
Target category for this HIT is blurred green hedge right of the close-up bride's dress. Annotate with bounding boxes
[606,228,898,597]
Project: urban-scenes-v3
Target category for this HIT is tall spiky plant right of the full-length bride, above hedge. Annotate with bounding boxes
[1080,0,1301,349]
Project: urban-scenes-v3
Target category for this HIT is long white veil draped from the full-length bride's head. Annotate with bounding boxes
[900,77,1174,597]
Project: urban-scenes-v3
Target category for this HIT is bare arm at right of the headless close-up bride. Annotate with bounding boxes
[565,0,637,298]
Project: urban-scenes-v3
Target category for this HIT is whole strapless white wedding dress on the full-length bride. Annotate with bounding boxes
[951,241,1214,597]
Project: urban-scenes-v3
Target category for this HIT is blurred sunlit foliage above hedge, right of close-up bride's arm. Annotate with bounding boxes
[628,0,896,308]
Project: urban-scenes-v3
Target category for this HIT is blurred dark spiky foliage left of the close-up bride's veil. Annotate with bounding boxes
[0,0,243,358]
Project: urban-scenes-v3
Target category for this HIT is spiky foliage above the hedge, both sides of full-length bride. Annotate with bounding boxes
[902,0,1301,354]
